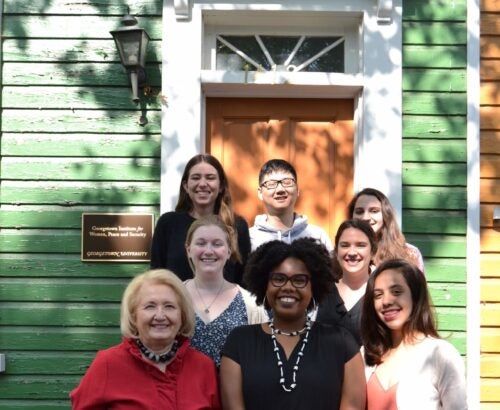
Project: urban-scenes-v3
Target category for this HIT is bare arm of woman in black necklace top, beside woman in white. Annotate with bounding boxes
[340,353,366,410]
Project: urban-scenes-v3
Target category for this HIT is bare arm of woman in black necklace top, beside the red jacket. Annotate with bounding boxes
[220,356,245,410]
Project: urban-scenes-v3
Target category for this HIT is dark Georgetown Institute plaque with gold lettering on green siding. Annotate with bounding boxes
[81,213,154,262]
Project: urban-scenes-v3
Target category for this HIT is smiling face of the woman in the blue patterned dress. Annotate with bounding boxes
[186,225,231,275]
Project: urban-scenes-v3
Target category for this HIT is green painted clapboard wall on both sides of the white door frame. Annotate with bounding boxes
[0,0,467,409]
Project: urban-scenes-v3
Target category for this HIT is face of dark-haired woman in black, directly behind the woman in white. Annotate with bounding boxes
[335,227,373,280]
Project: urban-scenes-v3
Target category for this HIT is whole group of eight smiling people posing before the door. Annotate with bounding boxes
[70,154,467,410]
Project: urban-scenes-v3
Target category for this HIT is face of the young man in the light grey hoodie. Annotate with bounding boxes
[258,170,299,215]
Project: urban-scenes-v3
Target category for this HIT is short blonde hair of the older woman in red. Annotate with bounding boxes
[120,269,195,338]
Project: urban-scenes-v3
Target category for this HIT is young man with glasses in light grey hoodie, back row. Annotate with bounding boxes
[250,159,332,251]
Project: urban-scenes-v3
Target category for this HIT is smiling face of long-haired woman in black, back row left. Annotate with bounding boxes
[182,162,221,212]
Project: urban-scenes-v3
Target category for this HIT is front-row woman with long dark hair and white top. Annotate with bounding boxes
[361,259,467,410]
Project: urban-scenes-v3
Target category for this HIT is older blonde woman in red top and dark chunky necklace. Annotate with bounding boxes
[70,269,221,410]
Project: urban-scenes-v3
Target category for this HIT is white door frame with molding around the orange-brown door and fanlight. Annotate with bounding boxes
[161,0,402,211]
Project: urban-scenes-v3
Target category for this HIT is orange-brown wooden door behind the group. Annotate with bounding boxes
[206,98,354,238]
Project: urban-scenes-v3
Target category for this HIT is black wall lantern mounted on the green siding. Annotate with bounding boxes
[110,13,149,104]
